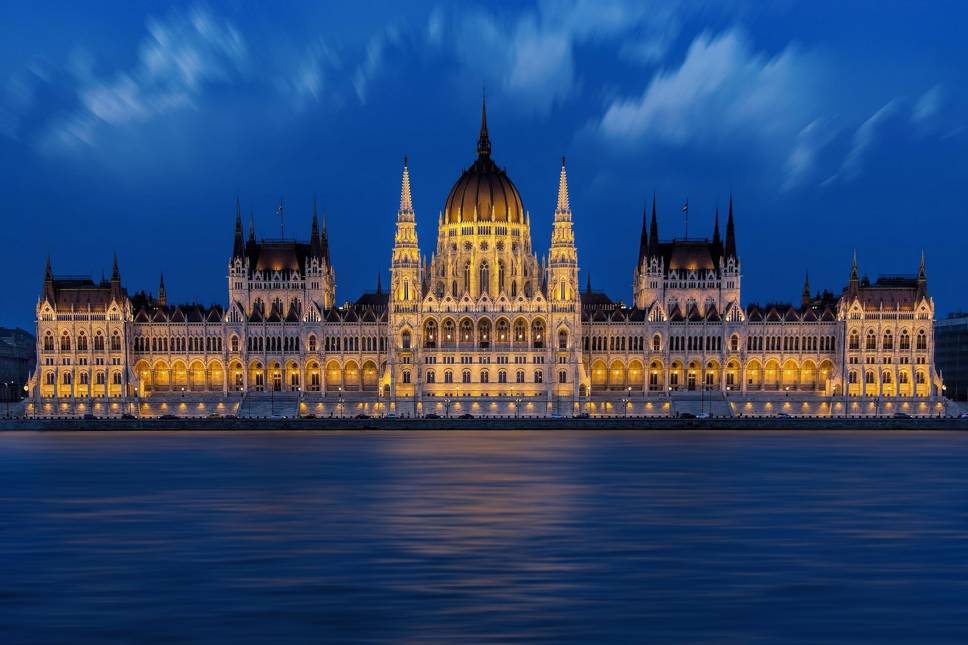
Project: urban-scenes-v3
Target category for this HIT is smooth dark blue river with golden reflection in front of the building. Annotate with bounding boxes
[0,431,968,643]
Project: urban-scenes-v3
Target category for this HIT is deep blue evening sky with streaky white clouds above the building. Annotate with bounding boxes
[0,0,968,327]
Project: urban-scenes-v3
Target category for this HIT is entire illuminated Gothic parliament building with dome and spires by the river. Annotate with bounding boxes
[28,101,941,416]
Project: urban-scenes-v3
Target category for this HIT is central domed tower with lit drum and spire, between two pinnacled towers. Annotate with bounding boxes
[429,103,541,301]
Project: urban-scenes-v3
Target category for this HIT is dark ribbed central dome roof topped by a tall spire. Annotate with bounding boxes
[444,98,524,224]
